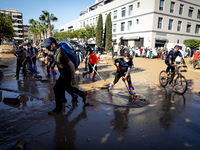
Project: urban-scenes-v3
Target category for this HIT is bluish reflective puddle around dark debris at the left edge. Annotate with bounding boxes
[0,91,42,110]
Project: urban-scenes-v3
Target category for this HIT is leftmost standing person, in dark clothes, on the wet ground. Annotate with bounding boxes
[14,46,27,78]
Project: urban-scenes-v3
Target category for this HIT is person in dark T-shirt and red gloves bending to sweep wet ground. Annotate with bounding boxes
[109,53,135,99]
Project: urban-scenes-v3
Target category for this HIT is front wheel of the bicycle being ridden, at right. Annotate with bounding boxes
[174,75,188,94]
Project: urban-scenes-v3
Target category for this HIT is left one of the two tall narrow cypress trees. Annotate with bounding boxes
[96,14,103,47]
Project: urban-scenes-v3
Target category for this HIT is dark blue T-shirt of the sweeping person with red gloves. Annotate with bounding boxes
[115,58,133,73]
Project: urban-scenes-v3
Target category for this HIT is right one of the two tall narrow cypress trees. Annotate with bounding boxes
[105,14,112,52]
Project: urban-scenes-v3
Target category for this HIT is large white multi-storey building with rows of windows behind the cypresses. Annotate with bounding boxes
[60,0,200,47]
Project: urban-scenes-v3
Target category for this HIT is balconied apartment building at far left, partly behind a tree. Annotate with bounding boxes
[0,8,23,43]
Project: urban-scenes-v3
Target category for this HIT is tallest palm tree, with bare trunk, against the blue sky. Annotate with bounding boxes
[39,10,58,37]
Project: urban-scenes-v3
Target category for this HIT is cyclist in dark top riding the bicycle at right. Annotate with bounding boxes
[165,45,185,75]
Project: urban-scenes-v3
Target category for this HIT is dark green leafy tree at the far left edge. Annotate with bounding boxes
[0,13,15,44]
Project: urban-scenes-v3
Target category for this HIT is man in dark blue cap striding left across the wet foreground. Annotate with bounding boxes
[43,37,87,115]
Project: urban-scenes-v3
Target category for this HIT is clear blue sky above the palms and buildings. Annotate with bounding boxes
[0,0,96,29]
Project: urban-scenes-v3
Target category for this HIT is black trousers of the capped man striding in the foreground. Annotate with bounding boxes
[54,71,84,111]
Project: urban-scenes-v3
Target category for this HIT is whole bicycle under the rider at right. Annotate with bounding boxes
[159,65,188,94]
